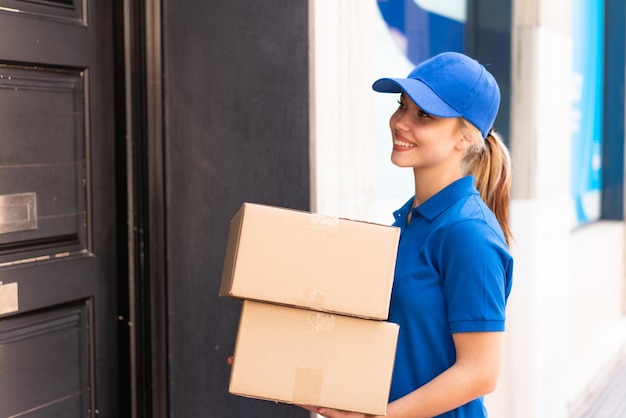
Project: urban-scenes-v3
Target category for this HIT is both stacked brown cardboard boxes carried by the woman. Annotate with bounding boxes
[220,203,399,415]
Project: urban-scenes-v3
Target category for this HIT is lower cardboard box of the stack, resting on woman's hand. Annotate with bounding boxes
[229,301,398,415]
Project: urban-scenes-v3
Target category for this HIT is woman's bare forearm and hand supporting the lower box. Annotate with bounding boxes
[306,332,503,418]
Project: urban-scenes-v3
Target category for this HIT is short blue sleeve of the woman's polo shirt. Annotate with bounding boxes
[439,219,512,333]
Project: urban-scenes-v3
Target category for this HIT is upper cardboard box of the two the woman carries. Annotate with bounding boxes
[220,203,400,320]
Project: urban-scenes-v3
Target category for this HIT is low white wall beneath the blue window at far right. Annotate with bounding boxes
[567,222,626,407]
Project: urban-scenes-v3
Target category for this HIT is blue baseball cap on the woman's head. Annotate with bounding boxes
[372,52,500,138]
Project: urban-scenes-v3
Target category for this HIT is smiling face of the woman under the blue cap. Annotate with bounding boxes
[389,93,464,171]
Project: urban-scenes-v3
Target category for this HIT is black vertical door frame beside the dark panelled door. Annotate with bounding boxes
[115,0,169,418]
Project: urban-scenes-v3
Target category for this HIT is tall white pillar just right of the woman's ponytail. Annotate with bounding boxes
[506,0,573,418]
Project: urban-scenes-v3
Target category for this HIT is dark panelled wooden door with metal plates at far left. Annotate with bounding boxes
[0,0,119,417]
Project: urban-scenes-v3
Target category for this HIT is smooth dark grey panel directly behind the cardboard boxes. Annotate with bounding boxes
[157,0,310,418]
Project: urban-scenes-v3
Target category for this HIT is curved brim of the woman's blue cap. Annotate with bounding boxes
[372,78,461,118]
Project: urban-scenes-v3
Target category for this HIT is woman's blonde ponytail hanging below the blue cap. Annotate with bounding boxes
[459,118,512,244]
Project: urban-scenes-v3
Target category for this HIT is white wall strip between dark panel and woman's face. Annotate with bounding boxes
[310,0,413,224]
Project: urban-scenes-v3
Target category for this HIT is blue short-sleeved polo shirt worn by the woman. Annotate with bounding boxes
[389,176,513,418]
